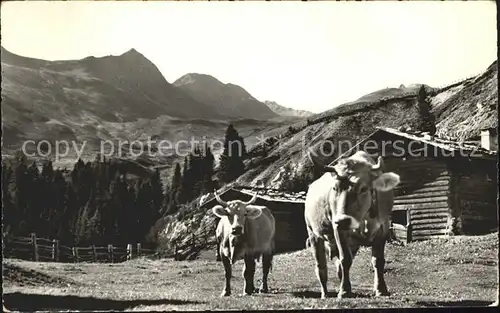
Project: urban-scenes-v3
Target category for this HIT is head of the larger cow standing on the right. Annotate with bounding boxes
[310,151,399,230]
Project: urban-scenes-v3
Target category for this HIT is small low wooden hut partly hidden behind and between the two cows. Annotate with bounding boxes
[200,185,307,253]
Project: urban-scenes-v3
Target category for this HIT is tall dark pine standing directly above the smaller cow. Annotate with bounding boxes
[220,124,246,182]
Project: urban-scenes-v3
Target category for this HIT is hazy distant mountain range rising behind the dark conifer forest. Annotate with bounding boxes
[1,47,304,167]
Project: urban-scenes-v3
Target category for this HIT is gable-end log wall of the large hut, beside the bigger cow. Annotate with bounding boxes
[363,133,453,240]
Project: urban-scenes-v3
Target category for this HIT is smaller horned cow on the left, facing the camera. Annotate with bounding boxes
[212,192,275,297]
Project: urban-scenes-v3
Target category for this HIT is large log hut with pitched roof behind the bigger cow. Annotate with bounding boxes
[332,128,498,242]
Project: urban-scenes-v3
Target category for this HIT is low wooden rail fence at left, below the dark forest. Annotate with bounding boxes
[4,233,156,263]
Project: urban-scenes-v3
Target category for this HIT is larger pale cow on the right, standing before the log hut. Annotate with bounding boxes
[304,151,400,299]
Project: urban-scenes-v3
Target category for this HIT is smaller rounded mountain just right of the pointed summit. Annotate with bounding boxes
[174,73,278,120]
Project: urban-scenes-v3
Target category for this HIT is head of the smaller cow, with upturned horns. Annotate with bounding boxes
[212,191,262,236]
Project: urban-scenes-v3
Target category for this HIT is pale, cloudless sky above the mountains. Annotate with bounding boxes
[1,1,497,113]
